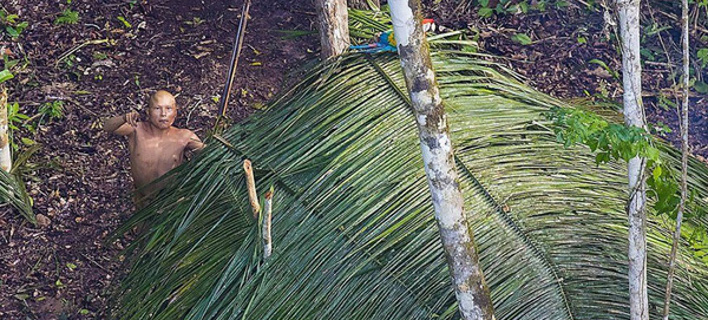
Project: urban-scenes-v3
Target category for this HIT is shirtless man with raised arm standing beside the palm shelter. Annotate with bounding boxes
[103,90,204,207]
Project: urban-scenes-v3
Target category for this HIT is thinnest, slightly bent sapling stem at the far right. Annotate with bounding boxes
[663,0,690,320]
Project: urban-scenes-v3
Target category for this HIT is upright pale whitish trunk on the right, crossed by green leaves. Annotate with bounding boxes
[617,0,649,320]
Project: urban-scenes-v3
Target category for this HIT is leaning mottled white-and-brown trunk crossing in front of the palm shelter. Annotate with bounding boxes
[388,0,494,320]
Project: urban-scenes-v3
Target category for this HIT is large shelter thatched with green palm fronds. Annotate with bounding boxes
[109,45,708,320]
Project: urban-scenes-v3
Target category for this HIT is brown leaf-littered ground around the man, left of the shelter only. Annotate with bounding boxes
[0,0,318,320]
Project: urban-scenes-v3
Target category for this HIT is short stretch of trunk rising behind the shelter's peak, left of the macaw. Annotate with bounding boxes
[316,0,349,59]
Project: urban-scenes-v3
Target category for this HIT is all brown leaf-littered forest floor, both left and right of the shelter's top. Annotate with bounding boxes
[0,0,708,320]
